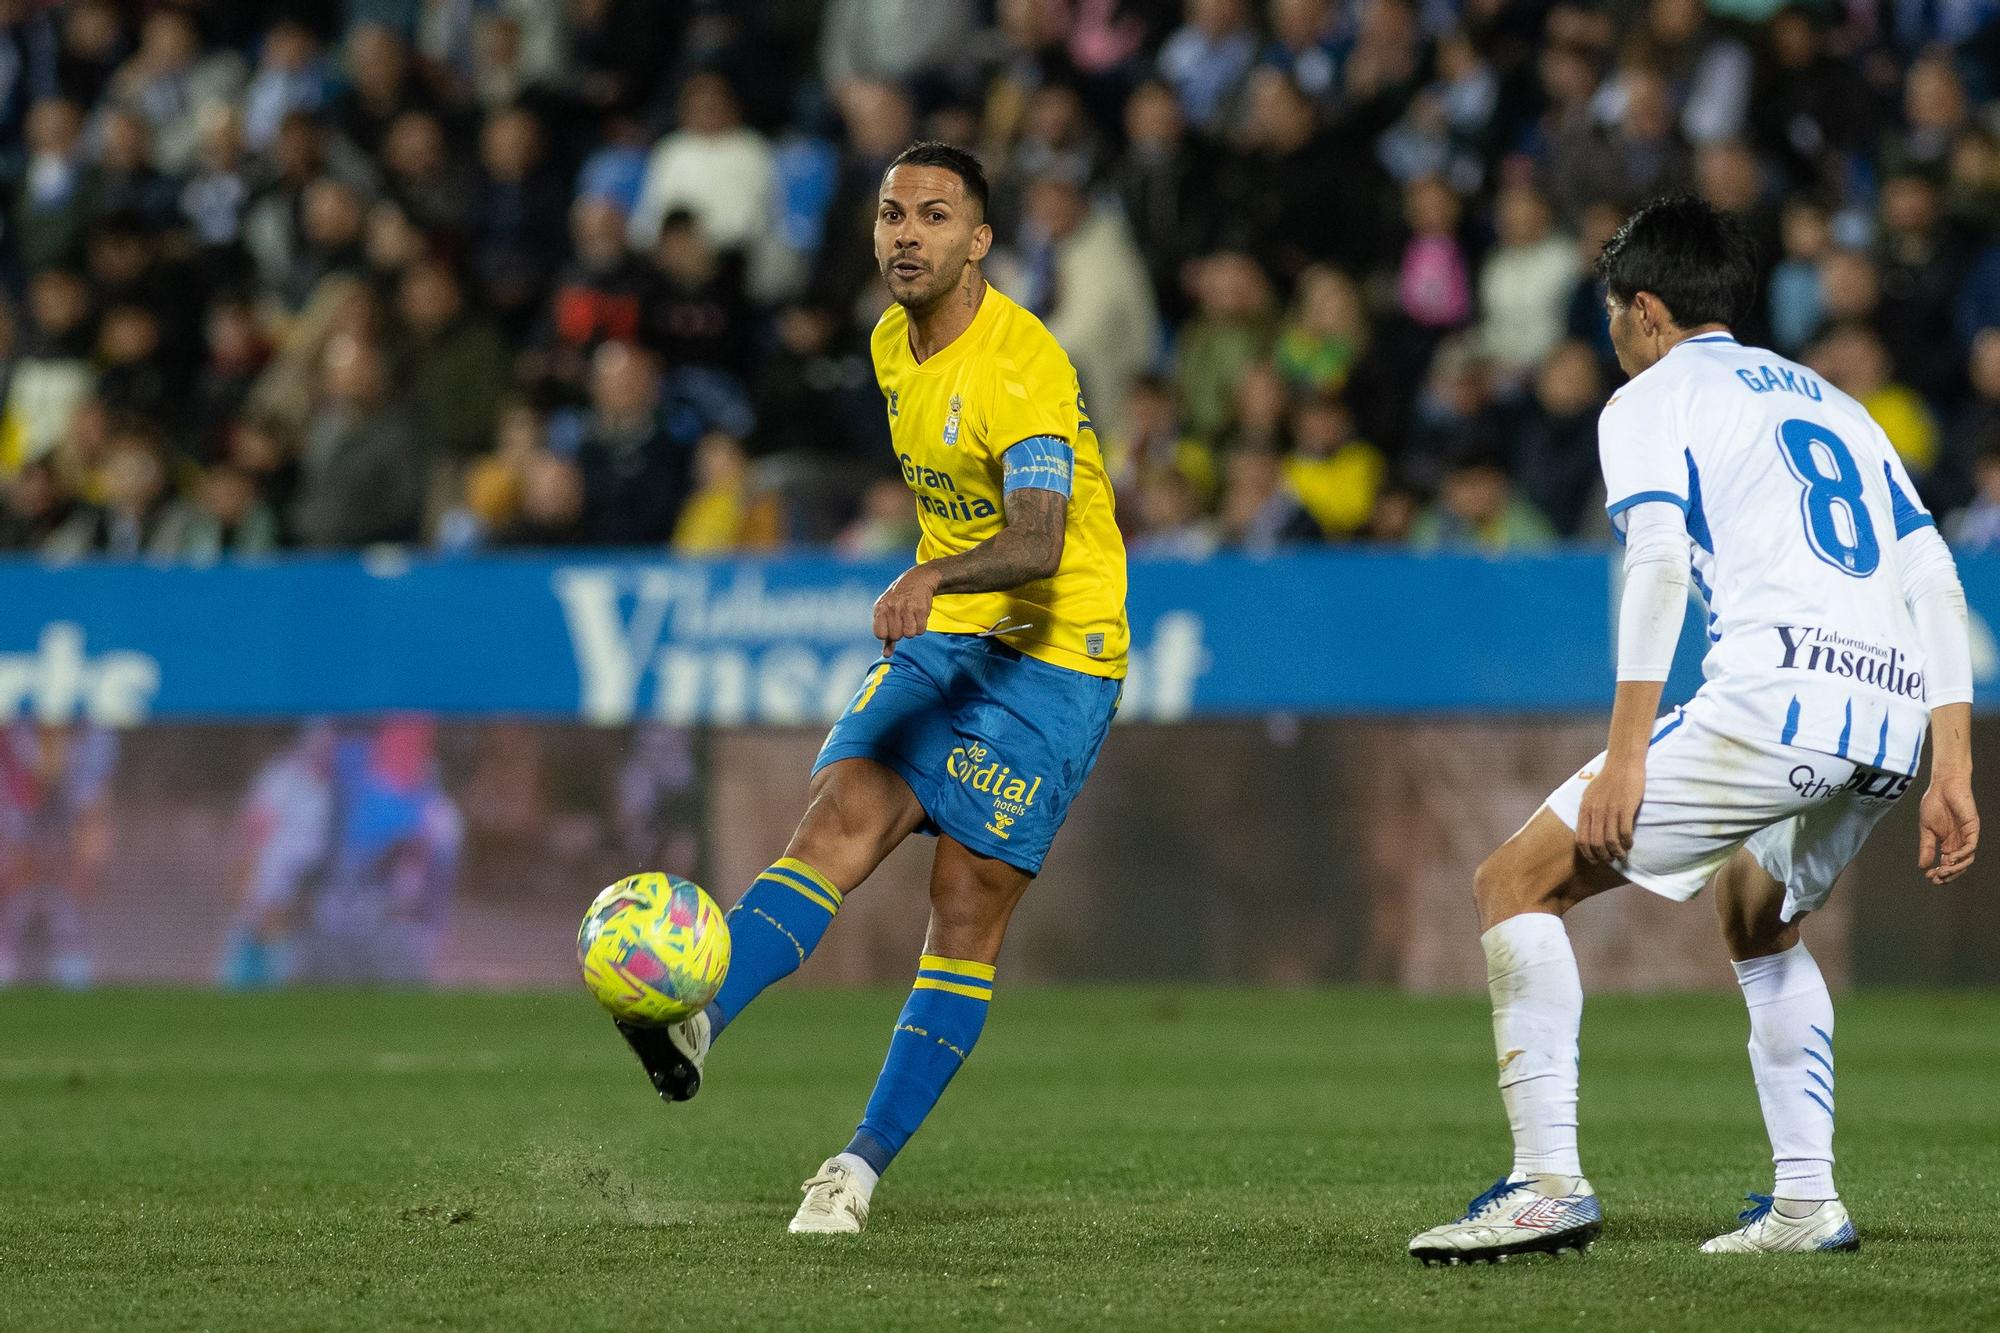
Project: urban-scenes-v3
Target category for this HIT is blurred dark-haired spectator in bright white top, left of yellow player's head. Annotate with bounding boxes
[630,72,776,252]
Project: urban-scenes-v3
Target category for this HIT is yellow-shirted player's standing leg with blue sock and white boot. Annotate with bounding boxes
[792,837,1030,1233]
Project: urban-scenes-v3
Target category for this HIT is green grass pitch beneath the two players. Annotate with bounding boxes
[0,989,2000,1333]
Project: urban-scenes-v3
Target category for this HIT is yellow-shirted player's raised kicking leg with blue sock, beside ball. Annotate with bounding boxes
[618,756,924,1101]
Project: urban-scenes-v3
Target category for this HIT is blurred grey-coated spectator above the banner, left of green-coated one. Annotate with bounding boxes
[292,332,428,546]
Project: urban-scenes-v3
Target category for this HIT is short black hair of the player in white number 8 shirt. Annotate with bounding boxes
[1596,194,1758,328]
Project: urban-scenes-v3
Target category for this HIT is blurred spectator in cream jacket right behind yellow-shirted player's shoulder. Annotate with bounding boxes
[992,174,1160,432]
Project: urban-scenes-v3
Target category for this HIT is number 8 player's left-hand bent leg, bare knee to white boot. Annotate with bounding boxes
[1410,807,1624,1263]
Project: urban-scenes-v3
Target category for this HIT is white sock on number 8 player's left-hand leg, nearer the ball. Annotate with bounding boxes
[1480,913,1584,1177]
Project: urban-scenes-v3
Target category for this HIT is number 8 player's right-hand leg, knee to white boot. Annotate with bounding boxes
[1702,851,1860,1255]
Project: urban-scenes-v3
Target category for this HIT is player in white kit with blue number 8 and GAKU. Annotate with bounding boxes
[1410,198,1980,1263]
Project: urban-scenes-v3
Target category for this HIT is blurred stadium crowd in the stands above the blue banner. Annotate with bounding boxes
[0,0,2000,558]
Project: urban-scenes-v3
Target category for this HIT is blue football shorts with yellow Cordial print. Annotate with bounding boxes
[812,630,1124,875]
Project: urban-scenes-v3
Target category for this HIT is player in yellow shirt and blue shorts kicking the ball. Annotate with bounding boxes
[620,142,1128,1233]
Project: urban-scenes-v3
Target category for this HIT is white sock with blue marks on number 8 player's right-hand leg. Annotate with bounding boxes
[1732,943,1840,1199]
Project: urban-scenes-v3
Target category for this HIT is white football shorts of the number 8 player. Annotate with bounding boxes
[1546,709,1910,921]
